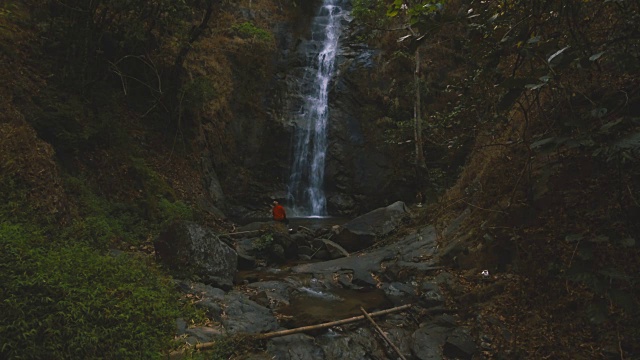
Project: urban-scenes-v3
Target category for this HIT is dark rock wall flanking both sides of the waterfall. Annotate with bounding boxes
[207,0,414,217]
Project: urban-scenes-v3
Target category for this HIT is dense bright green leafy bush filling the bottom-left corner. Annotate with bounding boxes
[0,222,179,359]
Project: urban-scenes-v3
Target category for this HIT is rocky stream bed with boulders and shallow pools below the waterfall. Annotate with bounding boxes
[155,202,480,360]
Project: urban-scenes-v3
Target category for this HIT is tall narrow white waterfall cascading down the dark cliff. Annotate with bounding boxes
[288,0,347,216]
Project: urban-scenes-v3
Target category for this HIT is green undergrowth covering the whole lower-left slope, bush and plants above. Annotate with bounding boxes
[0,156,200,359]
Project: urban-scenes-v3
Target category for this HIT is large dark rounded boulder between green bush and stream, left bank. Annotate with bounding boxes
[154,221,238,289]
